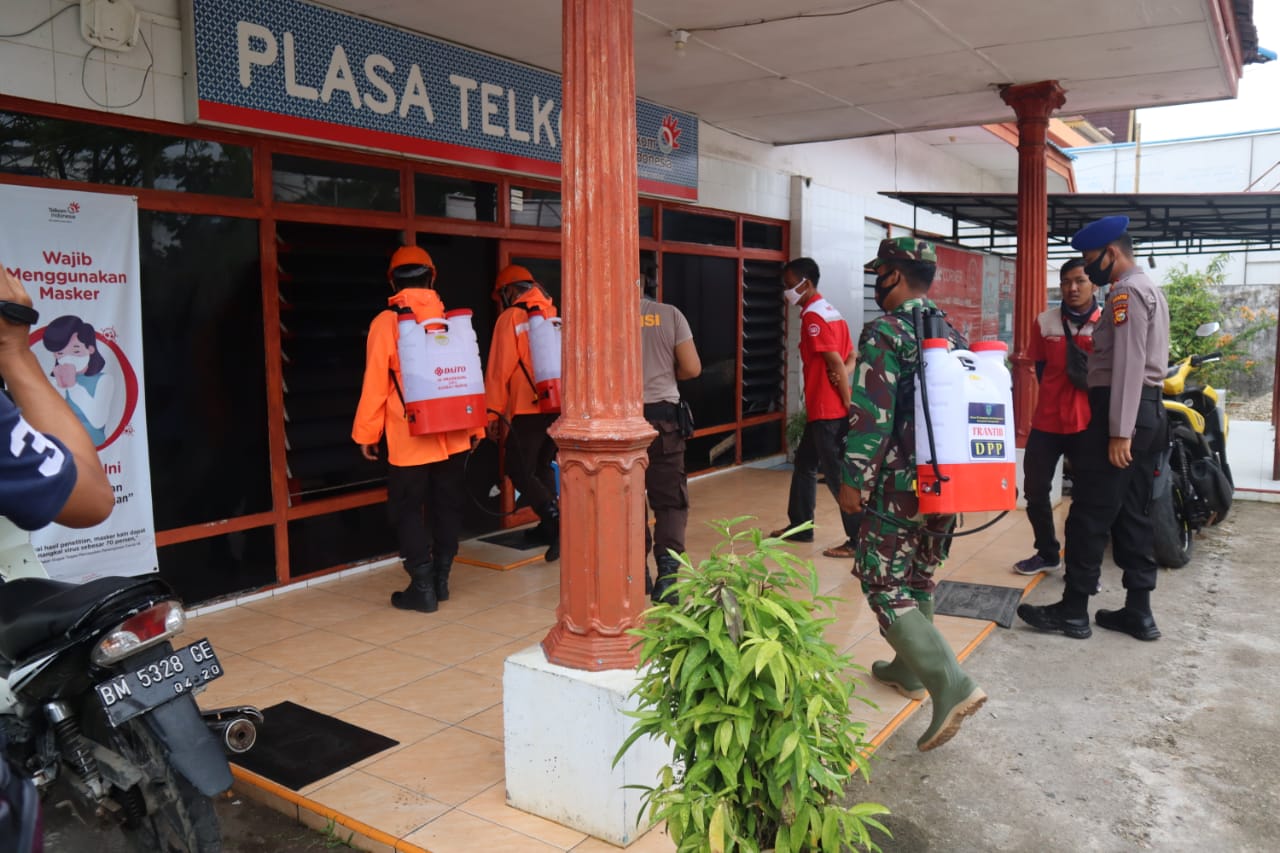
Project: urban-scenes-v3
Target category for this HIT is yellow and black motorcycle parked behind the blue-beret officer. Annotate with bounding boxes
[1151,323,1234,569]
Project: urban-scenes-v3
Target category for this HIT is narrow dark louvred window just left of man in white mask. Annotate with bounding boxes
[742,260,786,418]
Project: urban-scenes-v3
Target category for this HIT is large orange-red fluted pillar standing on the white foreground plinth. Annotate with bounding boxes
[543,0,655,670]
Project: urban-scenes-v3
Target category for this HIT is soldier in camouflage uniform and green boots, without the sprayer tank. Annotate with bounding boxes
[840,237,987,752]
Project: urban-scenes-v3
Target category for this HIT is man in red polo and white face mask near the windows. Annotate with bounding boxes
[772,257,861,560]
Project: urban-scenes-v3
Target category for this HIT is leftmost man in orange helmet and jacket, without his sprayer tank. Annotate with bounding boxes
[351,246,484,613]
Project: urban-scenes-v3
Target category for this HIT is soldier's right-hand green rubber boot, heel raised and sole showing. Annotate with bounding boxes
[884,611,987,752]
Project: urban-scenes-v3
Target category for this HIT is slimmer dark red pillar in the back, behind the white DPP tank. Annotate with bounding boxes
[1000,81,1066,447]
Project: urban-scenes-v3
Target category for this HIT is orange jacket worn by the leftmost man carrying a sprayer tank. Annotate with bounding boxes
[351,287,483,467]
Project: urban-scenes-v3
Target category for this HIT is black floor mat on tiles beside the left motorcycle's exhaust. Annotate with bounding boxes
[230,702,399,790]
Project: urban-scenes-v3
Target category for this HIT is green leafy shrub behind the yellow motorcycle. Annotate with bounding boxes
[1165,255,1276,391]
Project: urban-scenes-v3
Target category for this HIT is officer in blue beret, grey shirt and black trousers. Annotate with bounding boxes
[1018,216,1169,640]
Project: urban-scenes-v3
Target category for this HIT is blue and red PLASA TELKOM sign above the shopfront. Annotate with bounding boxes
[183,0,698,200]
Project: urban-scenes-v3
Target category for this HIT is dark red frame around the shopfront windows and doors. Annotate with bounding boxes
[0,95,790,584]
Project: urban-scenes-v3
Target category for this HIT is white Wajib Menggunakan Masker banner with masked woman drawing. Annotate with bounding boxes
[0,184,156,583]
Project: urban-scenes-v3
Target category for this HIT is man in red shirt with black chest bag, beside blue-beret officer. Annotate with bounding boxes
[1014,257,1102,575]
